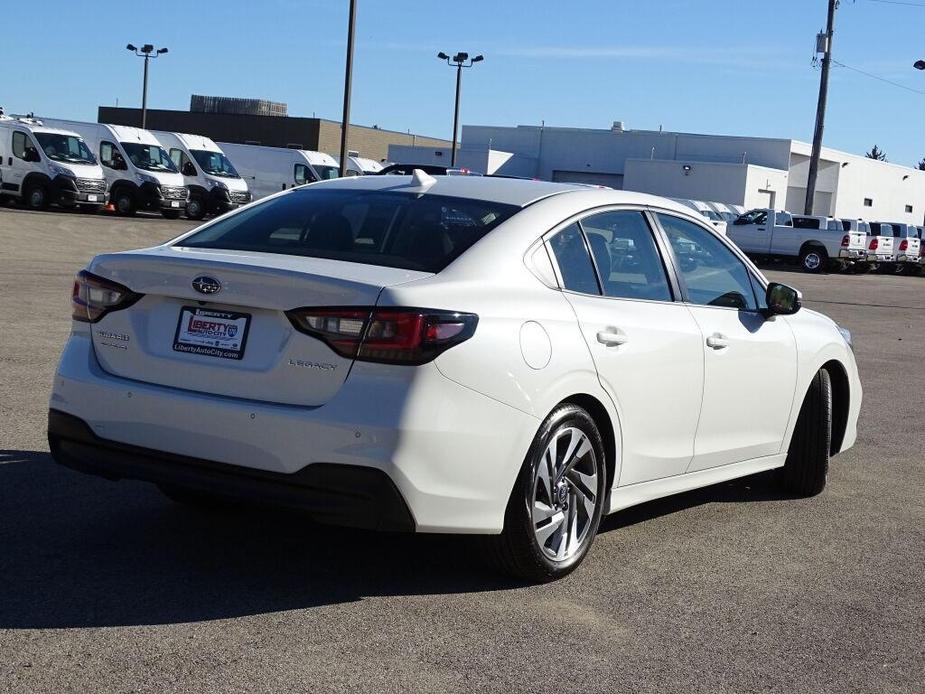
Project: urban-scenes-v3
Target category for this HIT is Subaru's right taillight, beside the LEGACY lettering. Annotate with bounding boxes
[286,307,478,364]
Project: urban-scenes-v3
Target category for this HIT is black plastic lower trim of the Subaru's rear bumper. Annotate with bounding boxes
[48,410,414,531]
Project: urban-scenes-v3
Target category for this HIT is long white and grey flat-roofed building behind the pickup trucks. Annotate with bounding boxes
[389,122,925,224]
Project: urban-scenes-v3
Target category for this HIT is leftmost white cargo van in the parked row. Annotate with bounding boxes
[0,116,106,212]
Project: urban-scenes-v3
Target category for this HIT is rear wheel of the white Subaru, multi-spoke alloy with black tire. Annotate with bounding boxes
[486,404,607,583]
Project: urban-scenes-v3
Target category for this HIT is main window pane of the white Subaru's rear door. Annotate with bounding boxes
[581,211,672,301]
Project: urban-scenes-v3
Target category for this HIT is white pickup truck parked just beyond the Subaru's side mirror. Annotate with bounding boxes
[727,209,867,272]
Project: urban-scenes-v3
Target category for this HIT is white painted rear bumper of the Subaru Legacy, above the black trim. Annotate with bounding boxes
[50,332,540,533]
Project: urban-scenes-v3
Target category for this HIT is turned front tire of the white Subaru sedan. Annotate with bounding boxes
[781,369,832,497]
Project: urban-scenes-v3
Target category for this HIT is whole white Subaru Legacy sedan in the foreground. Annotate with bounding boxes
[48,171,861,581]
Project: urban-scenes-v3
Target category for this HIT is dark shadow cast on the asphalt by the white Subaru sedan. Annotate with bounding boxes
[0,451,777,629]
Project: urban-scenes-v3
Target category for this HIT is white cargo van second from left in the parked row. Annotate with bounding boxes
[44,118,187,219]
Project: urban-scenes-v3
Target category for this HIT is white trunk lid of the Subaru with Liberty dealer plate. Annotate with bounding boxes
[89,246,430,406]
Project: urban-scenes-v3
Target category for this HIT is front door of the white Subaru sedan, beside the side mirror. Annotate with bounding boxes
[657,213,797,471]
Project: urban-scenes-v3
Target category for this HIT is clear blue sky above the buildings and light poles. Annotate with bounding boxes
[7,0,925,165]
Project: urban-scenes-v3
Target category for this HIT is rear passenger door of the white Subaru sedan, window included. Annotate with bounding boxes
[548,210,703,486]
